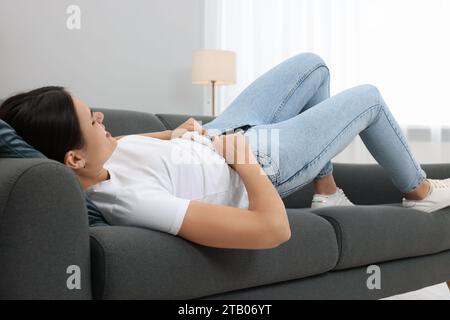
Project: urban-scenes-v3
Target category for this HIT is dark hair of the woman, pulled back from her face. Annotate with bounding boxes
[0,86,85,163]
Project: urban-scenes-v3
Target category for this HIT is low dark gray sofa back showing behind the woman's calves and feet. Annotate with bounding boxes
[283,163,450,208]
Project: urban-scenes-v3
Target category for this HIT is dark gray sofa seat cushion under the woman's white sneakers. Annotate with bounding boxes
[311,203,450,270]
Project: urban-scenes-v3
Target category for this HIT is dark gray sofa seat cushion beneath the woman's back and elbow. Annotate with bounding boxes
[91,209,338,299]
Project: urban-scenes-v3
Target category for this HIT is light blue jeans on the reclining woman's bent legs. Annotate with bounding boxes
[204,53,426,197]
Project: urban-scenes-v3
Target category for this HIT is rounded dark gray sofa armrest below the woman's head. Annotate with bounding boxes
[0,159,92,299]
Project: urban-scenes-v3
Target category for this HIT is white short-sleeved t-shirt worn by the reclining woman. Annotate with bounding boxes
[86,135,248,235]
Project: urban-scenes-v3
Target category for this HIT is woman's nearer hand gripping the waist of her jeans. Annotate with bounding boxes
[212,132,257,169]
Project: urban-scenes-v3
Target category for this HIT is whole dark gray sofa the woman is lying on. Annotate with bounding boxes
[0,109,450,299]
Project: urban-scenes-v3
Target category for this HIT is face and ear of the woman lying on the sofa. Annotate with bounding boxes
[64,97,117,171]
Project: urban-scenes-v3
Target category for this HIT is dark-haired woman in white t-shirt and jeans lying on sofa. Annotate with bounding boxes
[0,53,450,249]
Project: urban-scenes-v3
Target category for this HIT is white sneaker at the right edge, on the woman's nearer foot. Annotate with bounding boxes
[402,179,450,213]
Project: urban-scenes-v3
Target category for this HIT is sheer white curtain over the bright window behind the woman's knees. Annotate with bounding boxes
[204,0,450,163]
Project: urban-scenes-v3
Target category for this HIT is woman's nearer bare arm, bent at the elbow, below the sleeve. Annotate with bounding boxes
[178,135,291,249]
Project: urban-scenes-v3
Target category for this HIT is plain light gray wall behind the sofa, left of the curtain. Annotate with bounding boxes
[0,0,204,114]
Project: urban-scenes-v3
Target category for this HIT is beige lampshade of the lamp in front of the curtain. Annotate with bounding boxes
[192,50,236,85]
